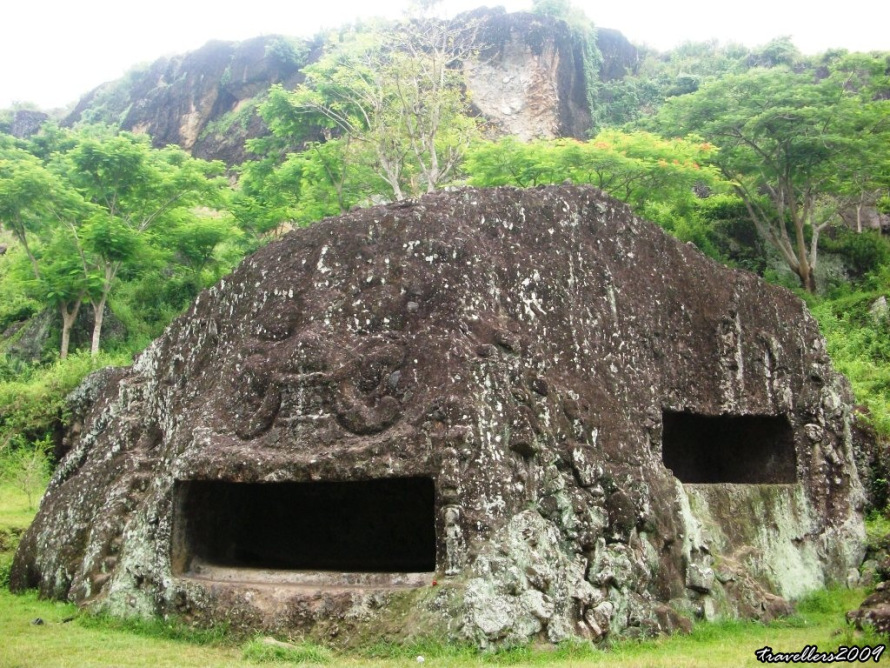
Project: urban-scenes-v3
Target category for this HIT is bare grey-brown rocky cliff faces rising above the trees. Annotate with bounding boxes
[65,9,637,165]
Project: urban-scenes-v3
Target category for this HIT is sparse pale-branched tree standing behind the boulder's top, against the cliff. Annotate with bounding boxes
[260,11,477,204]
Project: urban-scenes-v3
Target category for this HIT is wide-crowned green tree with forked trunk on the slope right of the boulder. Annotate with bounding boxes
[658,68,890,292]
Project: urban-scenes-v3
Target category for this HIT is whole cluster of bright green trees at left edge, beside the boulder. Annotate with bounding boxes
[0,126,236,366]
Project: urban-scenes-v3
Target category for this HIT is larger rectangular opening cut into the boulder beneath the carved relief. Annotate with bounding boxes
[171,478,436,574]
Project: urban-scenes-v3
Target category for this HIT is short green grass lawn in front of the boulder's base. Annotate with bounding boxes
[0,485,876,668]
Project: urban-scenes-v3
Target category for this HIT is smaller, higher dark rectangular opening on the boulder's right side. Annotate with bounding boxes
[662,411,797,484]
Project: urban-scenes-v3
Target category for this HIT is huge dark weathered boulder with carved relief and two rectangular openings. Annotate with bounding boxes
[12,187,864,646]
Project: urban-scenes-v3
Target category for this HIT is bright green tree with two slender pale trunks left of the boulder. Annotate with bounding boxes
[23,131,226,357]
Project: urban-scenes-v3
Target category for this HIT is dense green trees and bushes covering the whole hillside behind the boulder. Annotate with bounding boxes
[0,0,890,552]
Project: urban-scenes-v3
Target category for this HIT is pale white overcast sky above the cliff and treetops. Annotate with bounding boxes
[0,0,890,109]
